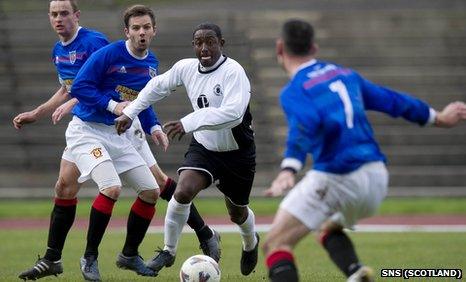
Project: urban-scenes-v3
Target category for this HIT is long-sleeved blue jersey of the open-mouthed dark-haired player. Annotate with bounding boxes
[71,40,160,134]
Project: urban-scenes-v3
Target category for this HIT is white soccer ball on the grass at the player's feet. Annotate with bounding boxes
[180,255,221,282]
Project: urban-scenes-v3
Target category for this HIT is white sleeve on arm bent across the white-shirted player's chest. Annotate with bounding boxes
[181,65,251,132]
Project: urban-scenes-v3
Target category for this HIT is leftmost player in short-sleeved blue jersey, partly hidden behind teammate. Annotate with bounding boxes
[13,0,219,279]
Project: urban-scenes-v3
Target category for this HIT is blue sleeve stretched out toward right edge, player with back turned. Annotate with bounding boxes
[356,71,435,125]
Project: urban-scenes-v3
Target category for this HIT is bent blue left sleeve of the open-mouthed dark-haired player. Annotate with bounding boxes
[71,49,112,110]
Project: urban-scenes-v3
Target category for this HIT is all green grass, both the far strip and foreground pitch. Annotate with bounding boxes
[0,198,466,281]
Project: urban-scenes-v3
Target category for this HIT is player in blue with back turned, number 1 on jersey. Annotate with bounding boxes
[263,20,466,282]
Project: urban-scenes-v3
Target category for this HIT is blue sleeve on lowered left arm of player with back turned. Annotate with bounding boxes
[280,89,320,171]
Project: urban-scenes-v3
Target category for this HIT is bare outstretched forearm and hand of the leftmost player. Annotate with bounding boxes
[13,87,70,129]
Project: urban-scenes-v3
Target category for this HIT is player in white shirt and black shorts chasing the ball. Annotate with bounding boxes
[116,23,259,275]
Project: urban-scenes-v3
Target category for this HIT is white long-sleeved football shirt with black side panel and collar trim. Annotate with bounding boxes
[123,56,253,152]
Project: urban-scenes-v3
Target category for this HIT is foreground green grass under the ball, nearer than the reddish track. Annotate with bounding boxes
[0,230,466,281]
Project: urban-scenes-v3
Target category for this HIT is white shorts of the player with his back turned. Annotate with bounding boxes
[280,162,388,231]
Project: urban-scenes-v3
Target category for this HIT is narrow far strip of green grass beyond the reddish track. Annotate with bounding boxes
[0,198,466,219]
